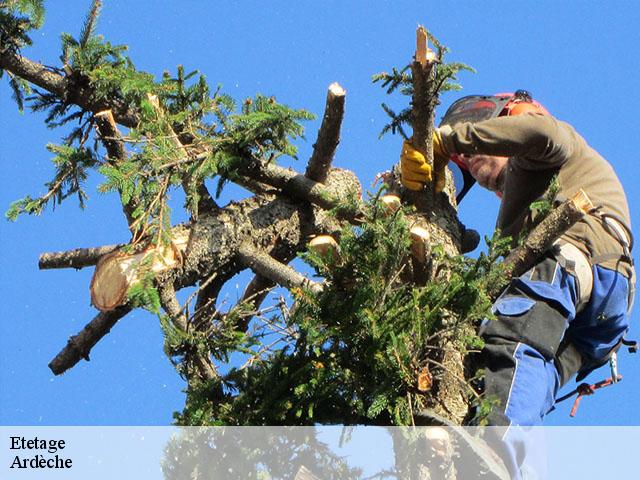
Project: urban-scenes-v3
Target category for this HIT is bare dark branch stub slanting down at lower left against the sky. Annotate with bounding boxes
[49,305,131,375]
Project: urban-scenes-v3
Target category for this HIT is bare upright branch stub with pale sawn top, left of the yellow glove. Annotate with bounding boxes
[305,83,346,183]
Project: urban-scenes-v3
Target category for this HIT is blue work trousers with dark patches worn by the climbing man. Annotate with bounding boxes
[481,257,630,478]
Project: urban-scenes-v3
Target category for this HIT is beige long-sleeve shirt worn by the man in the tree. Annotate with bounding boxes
[440,113,633,278]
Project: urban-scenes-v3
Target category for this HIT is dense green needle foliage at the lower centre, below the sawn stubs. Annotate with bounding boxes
[177,193,508,425]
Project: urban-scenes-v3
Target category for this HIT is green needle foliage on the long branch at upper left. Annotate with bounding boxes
[5,0,313,248]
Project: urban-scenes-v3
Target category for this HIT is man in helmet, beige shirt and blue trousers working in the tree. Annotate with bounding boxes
[401,91,634,476]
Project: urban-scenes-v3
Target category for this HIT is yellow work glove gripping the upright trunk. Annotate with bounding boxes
[400,132,449,193]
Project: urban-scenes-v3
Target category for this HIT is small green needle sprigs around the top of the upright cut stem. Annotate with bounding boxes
[372,33,475,139]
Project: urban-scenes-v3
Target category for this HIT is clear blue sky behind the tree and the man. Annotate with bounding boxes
[0,0,640,425]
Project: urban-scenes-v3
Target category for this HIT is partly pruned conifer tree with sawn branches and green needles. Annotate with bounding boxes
[0,0,580,436]
